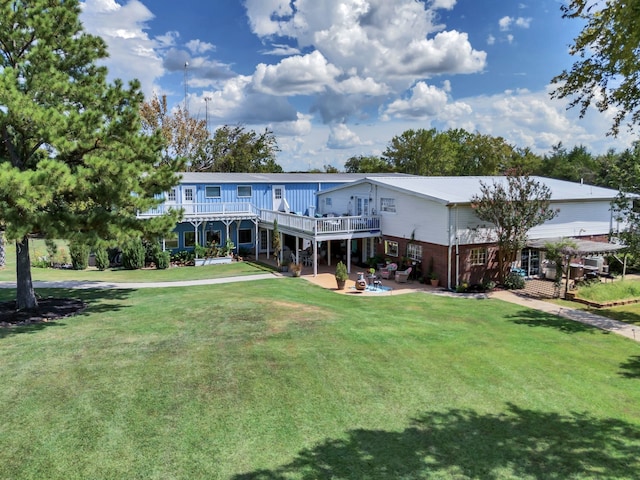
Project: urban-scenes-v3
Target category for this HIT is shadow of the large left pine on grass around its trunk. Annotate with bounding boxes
[0,288,134,340]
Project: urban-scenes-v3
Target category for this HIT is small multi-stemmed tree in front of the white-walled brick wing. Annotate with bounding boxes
[471,173,558,282]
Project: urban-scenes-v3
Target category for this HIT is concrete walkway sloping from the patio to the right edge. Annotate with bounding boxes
[490,290,640,342]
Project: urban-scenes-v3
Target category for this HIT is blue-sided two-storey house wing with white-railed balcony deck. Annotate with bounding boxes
[139,172,405,274]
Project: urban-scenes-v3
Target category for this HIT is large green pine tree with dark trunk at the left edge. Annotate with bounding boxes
[0,0,178,309]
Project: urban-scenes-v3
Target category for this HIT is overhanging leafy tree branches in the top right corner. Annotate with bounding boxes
[551,0,640,135]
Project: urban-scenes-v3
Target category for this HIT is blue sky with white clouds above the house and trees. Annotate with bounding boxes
[81,0,633,171]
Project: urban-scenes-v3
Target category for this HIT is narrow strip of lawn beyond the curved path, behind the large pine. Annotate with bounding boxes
[0,240,272,282]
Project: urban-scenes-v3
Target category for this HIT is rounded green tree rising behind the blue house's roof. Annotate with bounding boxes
[191,125,282,173]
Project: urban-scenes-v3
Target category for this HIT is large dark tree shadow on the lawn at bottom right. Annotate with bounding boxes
[233,404,640,480]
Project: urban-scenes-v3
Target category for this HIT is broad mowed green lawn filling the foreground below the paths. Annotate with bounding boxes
[0,278,640,479]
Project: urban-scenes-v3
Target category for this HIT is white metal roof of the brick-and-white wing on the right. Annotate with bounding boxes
[332,176,618,204]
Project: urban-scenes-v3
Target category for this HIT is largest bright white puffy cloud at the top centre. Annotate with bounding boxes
[245,0,486,92]
